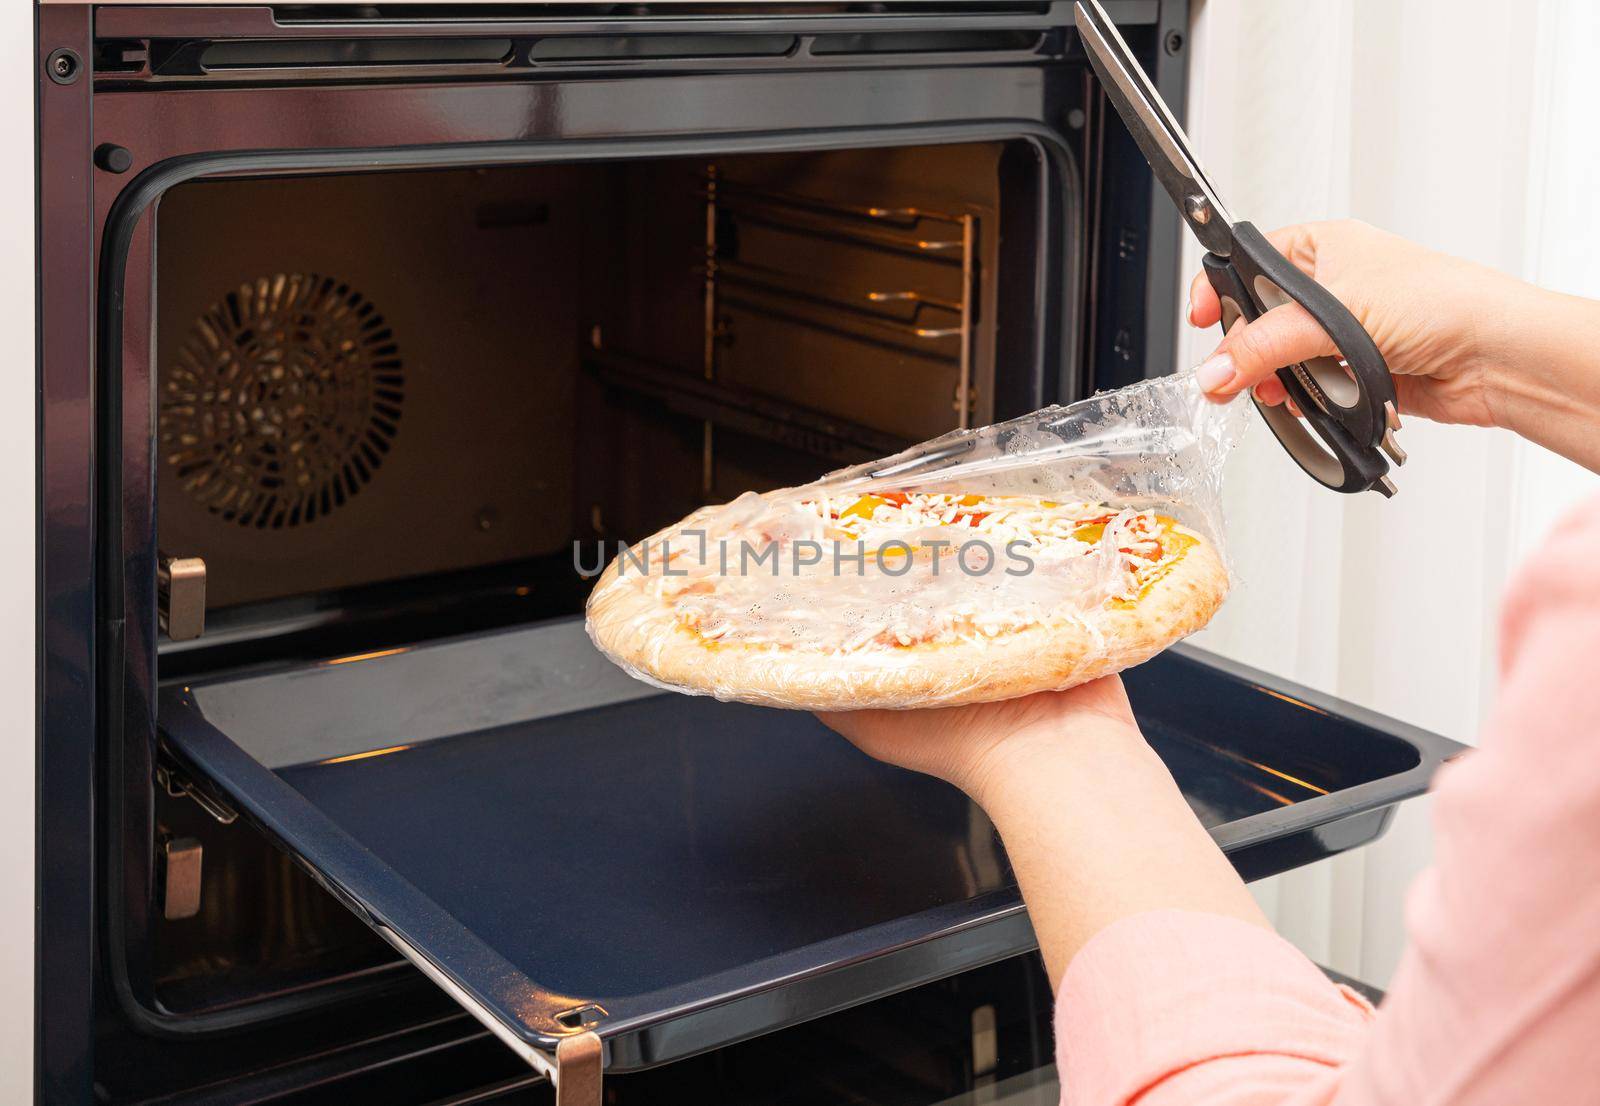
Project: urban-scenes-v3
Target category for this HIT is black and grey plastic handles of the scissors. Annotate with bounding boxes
[1205,222,1397,495]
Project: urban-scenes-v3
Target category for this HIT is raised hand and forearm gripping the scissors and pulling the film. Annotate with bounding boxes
[1189,219,1600,471]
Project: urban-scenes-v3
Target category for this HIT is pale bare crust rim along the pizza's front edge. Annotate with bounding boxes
[587,512,1229,711]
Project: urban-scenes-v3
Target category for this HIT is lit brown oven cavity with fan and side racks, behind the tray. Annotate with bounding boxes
[142,141,1054,1020]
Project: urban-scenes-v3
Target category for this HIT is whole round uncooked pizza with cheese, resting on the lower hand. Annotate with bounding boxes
[587,483,1227,711]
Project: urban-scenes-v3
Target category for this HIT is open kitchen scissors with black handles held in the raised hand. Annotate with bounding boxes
[1075,0,1405,496]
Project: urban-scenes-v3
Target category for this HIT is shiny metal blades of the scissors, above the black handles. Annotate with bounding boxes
[1074,0,1234,258]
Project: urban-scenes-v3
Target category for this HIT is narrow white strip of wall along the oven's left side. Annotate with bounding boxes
[0,3,38,1103]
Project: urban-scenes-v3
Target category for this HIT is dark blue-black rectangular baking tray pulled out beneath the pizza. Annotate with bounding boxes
[160,621,1461,1071]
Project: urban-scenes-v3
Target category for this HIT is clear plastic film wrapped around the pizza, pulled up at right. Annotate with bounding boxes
[587,373,1243,711]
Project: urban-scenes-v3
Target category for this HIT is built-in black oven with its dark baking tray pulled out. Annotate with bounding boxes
[38,0,1453,1106]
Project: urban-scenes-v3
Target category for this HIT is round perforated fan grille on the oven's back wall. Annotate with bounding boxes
[158,272,405,530]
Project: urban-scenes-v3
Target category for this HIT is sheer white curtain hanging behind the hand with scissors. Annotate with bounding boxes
[1179,0,1600,984]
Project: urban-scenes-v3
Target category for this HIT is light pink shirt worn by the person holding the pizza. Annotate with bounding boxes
[1056,499,1600,1106]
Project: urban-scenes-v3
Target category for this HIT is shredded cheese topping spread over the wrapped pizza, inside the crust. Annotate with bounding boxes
[646,491,1195,653]
